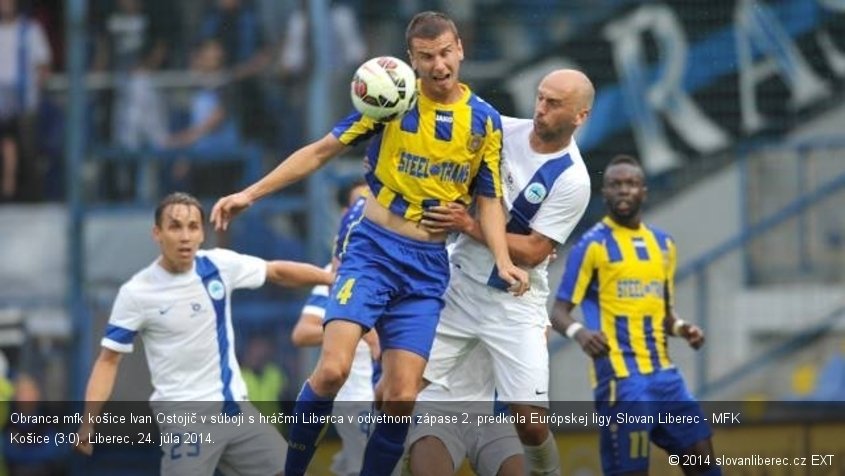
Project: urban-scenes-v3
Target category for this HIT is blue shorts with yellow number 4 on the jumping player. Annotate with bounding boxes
[324,219,449,359]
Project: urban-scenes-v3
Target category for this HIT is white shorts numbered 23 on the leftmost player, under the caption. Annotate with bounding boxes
[157,402,288,476]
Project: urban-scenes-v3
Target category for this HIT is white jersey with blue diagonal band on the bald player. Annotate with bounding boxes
[449,116,590,298]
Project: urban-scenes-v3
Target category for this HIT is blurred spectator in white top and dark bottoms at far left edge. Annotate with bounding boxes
[0,0,52,200]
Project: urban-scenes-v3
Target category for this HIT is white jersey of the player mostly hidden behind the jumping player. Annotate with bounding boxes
[302,280,374,402]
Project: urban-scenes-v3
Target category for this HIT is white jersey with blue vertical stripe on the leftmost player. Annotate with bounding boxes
[102,248,267,401]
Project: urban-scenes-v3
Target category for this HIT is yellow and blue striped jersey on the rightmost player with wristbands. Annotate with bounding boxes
[557,217,676,382]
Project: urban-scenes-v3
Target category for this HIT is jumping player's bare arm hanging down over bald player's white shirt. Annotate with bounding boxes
[476,195,529,296]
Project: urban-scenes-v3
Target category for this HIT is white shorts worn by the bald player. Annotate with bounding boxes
[424,268,549,408]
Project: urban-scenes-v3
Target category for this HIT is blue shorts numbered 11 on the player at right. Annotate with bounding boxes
[595,369,712,475]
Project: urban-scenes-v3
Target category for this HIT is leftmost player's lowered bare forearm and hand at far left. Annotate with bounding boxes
[74,348,123,456]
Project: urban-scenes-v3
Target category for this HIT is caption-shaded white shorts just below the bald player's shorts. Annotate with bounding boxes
[407,412,523,476]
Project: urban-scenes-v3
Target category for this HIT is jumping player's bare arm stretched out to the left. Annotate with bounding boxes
[210,134,346,230]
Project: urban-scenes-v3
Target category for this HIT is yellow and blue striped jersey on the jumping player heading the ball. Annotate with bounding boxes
[332,84,502,221]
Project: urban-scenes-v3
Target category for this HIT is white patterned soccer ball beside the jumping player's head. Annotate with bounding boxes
[350,56,417,122]
